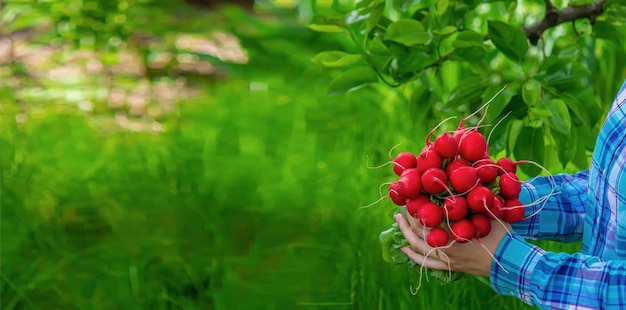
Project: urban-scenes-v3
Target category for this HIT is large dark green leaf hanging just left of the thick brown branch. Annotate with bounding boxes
[487,20,528,62]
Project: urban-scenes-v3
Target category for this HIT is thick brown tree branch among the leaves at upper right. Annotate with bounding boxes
[522,0,606,45]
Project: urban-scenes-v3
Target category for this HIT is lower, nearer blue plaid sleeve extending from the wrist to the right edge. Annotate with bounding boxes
[490,233,626,309]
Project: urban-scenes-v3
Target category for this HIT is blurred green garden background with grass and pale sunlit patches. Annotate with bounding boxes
[0,0,620,310]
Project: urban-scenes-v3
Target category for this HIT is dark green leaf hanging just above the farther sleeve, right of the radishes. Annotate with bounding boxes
[513,126,545,176]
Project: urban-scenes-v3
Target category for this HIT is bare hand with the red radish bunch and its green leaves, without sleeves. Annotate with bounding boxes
[370,88,545,283]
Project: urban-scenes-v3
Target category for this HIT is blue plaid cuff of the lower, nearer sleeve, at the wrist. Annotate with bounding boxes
[489,232,545,304]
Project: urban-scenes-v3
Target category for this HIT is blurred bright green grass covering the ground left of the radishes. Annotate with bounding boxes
[0,65,572,310]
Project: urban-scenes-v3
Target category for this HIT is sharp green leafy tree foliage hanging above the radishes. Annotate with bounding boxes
[310,0,626,175]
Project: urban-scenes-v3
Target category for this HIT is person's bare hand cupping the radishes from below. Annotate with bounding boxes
[394,214,511,277]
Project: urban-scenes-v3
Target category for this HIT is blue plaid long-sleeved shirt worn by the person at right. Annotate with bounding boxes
[490,82,626,309]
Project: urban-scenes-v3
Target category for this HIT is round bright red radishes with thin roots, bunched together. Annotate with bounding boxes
[388,117,524,248]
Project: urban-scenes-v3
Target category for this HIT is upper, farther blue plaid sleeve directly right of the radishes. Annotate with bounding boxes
[512,170,589,242]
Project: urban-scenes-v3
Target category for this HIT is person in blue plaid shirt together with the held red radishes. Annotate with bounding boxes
[372,81,626,309]
